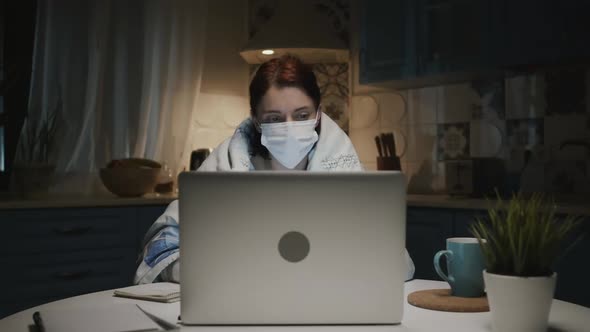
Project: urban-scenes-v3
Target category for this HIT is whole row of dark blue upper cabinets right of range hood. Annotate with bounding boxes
[359,0,590,88]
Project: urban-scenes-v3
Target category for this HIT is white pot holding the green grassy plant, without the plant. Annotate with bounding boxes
[483,270,557,332]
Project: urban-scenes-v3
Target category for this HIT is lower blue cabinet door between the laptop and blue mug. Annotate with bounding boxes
[406,207,453,280]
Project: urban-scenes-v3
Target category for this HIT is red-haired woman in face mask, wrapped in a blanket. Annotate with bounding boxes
[134,55,414,284]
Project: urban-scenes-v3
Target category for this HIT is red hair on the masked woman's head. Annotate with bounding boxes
[250,55,320,116]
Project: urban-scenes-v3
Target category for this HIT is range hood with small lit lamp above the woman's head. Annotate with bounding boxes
[240,0,349,64]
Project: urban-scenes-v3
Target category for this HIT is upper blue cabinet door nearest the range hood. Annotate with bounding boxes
[359,0,417,83]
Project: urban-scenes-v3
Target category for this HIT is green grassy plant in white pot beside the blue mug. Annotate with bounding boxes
[471,193,579,332]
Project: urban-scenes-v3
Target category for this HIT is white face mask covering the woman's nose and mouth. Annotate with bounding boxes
[260,111,320,169]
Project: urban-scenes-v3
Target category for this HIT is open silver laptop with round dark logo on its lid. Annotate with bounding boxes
[179,171,407,325]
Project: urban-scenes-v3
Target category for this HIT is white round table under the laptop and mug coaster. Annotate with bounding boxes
[0,280,590,332]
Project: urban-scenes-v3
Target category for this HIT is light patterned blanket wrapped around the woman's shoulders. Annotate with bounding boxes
[134,113,414,284]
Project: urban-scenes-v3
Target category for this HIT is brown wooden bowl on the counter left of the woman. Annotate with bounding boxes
[100,158,161,197]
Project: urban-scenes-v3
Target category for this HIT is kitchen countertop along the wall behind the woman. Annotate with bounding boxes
[0,193,590,216]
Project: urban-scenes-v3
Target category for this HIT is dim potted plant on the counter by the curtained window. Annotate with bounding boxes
[13,99,62,198]
